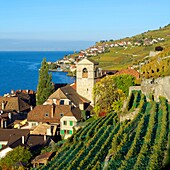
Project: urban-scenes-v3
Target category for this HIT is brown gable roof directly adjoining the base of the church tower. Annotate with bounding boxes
[48,85,90,107]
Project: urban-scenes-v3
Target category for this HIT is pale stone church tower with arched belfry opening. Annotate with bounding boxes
[76,58,99,105]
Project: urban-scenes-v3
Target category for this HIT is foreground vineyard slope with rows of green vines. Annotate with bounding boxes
[40,91,170,170]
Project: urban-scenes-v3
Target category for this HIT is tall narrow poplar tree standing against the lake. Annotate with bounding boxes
[36,58,54,105]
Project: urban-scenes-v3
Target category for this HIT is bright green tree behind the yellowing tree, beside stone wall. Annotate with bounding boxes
[113,74,135,96]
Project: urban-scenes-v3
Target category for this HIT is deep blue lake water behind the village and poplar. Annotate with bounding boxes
[0,51,74,95]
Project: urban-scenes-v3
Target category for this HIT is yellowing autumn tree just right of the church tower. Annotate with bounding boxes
[93,76,125,116]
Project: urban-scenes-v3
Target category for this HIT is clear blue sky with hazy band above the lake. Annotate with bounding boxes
[0,0,170,50]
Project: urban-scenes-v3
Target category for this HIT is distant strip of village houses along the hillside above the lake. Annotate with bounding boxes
[49,37,164,75]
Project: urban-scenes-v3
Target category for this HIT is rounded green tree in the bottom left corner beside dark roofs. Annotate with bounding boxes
[0,146,32,169]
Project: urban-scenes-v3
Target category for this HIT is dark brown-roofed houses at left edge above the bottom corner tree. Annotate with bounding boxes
[0,129,53,159]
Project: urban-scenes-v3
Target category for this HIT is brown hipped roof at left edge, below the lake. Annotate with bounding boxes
[0,97,30,112]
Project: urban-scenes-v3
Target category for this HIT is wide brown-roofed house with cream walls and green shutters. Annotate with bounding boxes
[27,104,86,138]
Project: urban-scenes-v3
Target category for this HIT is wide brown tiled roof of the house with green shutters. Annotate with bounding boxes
[27,104,71,123]
